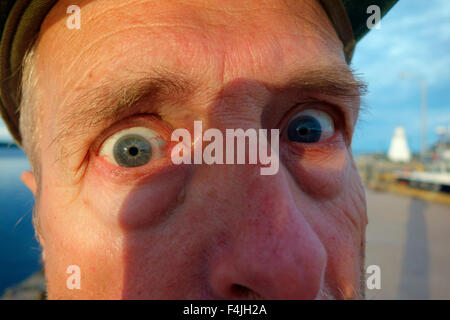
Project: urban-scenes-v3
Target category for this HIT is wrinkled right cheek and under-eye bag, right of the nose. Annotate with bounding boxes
[282,144,367,298]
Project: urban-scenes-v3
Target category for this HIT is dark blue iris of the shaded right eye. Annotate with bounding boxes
[287,115,322,143]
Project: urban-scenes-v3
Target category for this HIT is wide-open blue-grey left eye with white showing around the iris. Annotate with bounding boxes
[100,127,165,168]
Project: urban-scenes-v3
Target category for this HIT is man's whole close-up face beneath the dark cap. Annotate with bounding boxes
[26,0,367,299]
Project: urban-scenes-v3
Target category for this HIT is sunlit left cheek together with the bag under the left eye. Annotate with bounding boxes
[40,162,189,299]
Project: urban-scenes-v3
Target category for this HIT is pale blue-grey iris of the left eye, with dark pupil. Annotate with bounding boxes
[114,135,152,167]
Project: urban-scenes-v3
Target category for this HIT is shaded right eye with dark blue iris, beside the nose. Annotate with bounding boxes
[287,109,334,143]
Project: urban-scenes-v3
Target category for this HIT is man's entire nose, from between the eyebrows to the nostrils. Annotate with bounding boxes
[186,79,327,299]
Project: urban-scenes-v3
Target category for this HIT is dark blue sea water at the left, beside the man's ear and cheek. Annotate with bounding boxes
[0,145,42,296]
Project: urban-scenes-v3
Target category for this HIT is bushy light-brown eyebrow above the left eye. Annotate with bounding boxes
[52,70,194,152]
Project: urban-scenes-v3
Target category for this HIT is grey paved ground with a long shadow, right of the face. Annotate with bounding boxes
[366,190,450,299]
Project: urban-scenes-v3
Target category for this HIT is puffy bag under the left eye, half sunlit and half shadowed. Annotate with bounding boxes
[81,162,188,230]
